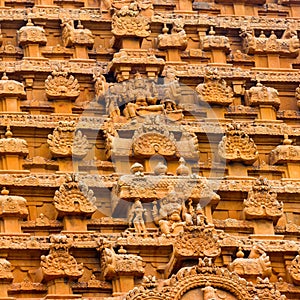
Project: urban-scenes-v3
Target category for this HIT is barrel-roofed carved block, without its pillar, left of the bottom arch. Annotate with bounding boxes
[101,245,145,280]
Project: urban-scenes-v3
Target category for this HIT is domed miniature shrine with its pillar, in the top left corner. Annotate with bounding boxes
[18,19,47,59]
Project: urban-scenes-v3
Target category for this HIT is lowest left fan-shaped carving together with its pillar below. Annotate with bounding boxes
[41,235,83,300]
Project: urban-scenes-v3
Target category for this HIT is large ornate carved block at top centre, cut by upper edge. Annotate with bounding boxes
[112,1,150,38]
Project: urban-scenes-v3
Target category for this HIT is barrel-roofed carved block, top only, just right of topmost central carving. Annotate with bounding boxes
[158,18,188,50]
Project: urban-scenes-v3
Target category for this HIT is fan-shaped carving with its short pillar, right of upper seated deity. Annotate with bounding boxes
[196,68,233,119]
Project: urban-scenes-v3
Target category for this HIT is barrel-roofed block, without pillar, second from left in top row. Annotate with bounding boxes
[62,20,94,47]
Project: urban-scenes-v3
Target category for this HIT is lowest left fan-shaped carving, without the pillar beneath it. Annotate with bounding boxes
[41,235,83,281]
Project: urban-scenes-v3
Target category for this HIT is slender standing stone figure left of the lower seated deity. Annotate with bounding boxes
[128,199,147,233]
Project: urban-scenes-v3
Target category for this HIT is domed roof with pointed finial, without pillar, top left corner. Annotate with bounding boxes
[18,19,47,45]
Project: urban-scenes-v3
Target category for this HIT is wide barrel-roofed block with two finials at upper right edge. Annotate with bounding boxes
[240,24,300,57]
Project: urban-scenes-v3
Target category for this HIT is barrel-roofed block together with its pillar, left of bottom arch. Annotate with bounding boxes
[101,246,145,297]
